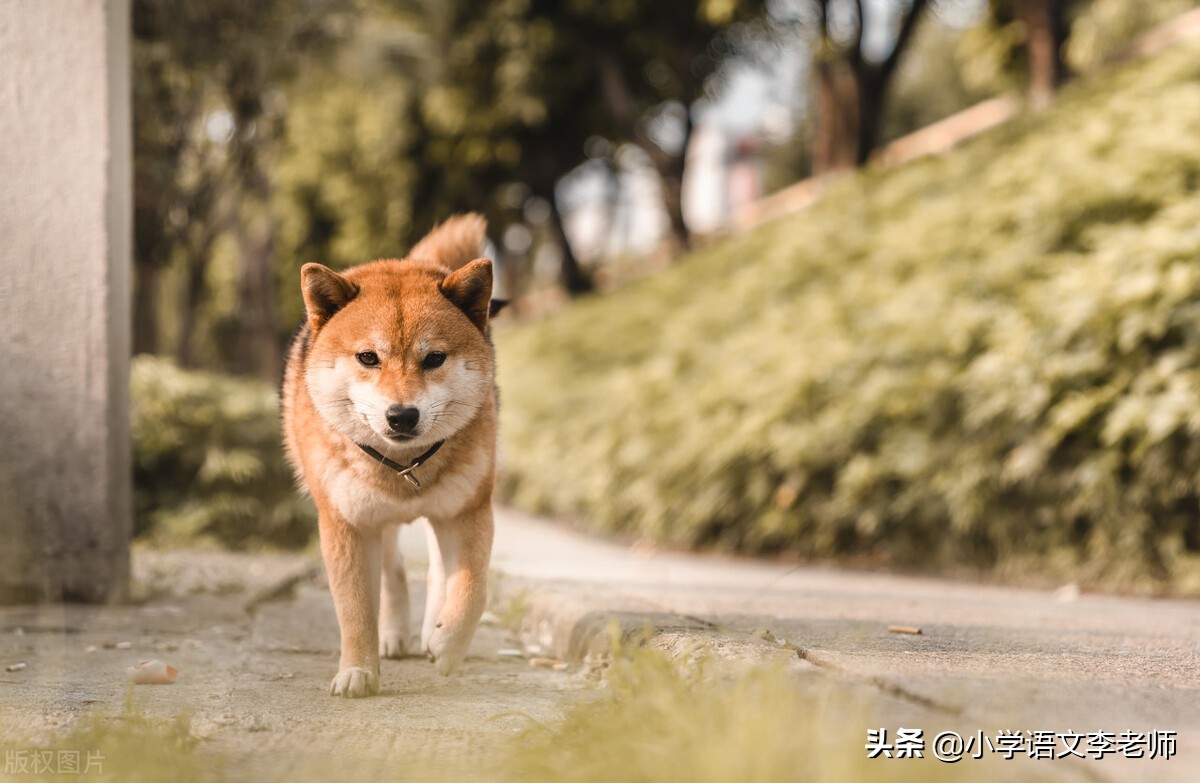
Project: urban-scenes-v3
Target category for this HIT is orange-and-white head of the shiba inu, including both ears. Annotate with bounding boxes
[301,259,494,454]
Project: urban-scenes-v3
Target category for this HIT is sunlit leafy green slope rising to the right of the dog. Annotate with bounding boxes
[498,44,1200,593]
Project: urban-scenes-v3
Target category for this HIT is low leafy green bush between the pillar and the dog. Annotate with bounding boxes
[132,357,316,549]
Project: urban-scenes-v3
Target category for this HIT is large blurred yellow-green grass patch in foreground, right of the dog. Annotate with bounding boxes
[506,648,964,783]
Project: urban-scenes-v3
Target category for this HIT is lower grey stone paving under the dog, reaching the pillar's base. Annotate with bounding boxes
[0,540,576,783]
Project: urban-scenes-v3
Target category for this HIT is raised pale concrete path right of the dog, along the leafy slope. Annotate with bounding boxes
[477,512,1200,782]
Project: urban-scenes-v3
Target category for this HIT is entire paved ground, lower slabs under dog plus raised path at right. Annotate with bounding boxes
[0,510,1200,782]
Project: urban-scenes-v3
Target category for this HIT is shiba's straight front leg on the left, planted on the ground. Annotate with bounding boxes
[319,514,382,698]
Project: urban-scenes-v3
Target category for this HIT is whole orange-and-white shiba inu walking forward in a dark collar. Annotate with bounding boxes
[282,215,497,697]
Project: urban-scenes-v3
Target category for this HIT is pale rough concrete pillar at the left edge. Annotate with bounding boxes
[0,0,132,603]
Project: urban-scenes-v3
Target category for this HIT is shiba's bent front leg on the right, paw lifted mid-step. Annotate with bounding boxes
[426,498,492,674]
